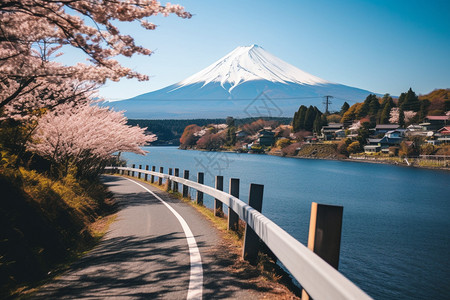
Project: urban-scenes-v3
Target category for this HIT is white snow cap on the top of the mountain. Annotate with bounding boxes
[176,45,329,92]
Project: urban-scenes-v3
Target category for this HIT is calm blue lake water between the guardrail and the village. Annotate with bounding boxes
[124,147,450,299]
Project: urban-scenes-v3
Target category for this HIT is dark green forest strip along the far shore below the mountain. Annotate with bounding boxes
[128,117,292,146]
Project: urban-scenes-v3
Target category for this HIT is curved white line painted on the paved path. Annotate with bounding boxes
[125,178,203,300]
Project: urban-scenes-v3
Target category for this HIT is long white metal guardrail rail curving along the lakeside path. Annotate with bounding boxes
[106,167,372,300]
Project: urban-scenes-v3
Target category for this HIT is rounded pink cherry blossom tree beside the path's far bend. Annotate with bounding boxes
[27,102,156,176]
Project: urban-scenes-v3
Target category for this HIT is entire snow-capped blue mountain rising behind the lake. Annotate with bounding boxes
[106,45,371,119]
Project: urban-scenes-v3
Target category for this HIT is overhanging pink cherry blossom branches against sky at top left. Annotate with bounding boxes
[0,0,191,108]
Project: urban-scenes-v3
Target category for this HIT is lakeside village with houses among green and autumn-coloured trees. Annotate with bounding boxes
[180,89,450,168]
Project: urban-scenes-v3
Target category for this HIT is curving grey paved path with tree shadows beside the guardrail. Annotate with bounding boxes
[32,176,270,299]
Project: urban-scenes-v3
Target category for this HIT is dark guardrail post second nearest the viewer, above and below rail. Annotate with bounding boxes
[242,183,264,265]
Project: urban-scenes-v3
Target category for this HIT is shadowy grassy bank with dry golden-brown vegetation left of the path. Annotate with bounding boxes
[0,168,113,298]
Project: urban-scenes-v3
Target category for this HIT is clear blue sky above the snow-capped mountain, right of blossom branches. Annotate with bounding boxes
[96,0,450,100]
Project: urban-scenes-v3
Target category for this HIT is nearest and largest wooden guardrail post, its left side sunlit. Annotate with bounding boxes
[302,202,344,300]
